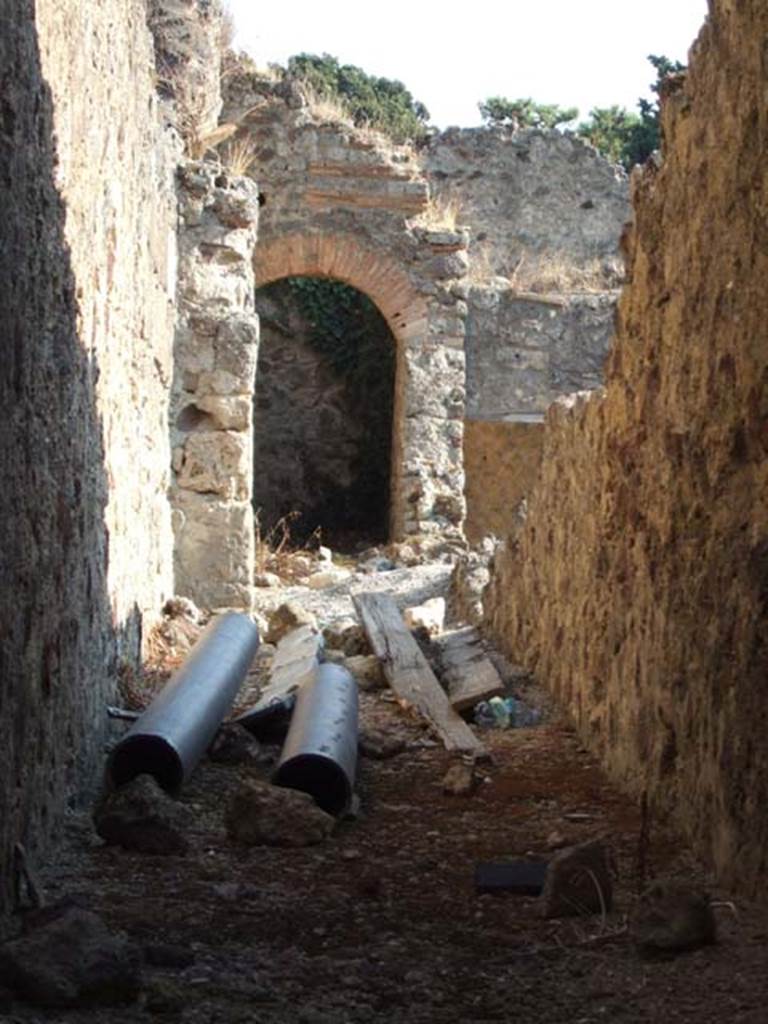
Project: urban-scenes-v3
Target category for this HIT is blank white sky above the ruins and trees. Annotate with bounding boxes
[226,0,707,128]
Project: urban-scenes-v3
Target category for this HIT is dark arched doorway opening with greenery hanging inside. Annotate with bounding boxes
[254,278,395,551]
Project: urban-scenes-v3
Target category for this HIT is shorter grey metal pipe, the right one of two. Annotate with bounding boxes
[272,664,357,815]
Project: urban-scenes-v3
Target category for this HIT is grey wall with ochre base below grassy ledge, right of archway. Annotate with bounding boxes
[464,286,616,543]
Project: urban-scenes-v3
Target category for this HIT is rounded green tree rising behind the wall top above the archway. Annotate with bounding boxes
[287,53,429,142]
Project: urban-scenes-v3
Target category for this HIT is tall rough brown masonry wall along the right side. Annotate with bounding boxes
[489,0,768,892]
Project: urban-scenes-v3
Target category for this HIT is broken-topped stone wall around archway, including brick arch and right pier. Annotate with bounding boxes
[223,75,468,538]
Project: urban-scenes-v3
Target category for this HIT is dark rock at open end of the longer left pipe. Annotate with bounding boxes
[93,775,190,854]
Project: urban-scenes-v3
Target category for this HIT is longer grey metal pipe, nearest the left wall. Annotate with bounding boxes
[108,611,259,793]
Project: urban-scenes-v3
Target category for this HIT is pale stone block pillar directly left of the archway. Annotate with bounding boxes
[171,162,259,609]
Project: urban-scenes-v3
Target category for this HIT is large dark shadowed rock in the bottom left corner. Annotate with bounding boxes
[0,903,140,1008]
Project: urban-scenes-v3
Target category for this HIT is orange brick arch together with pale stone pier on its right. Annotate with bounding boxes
[253,225,467,540]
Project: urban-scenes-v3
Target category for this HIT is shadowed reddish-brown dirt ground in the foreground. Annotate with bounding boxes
[6,671,768,1024]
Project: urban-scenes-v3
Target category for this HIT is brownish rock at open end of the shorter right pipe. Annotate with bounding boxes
[226,779,335,847]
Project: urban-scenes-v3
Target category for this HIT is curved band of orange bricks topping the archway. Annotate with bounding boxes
[254,234,428,341]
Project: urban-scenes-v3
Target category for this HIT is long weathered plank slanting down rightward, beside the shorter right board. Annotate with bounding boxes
[352,594,485,756]
